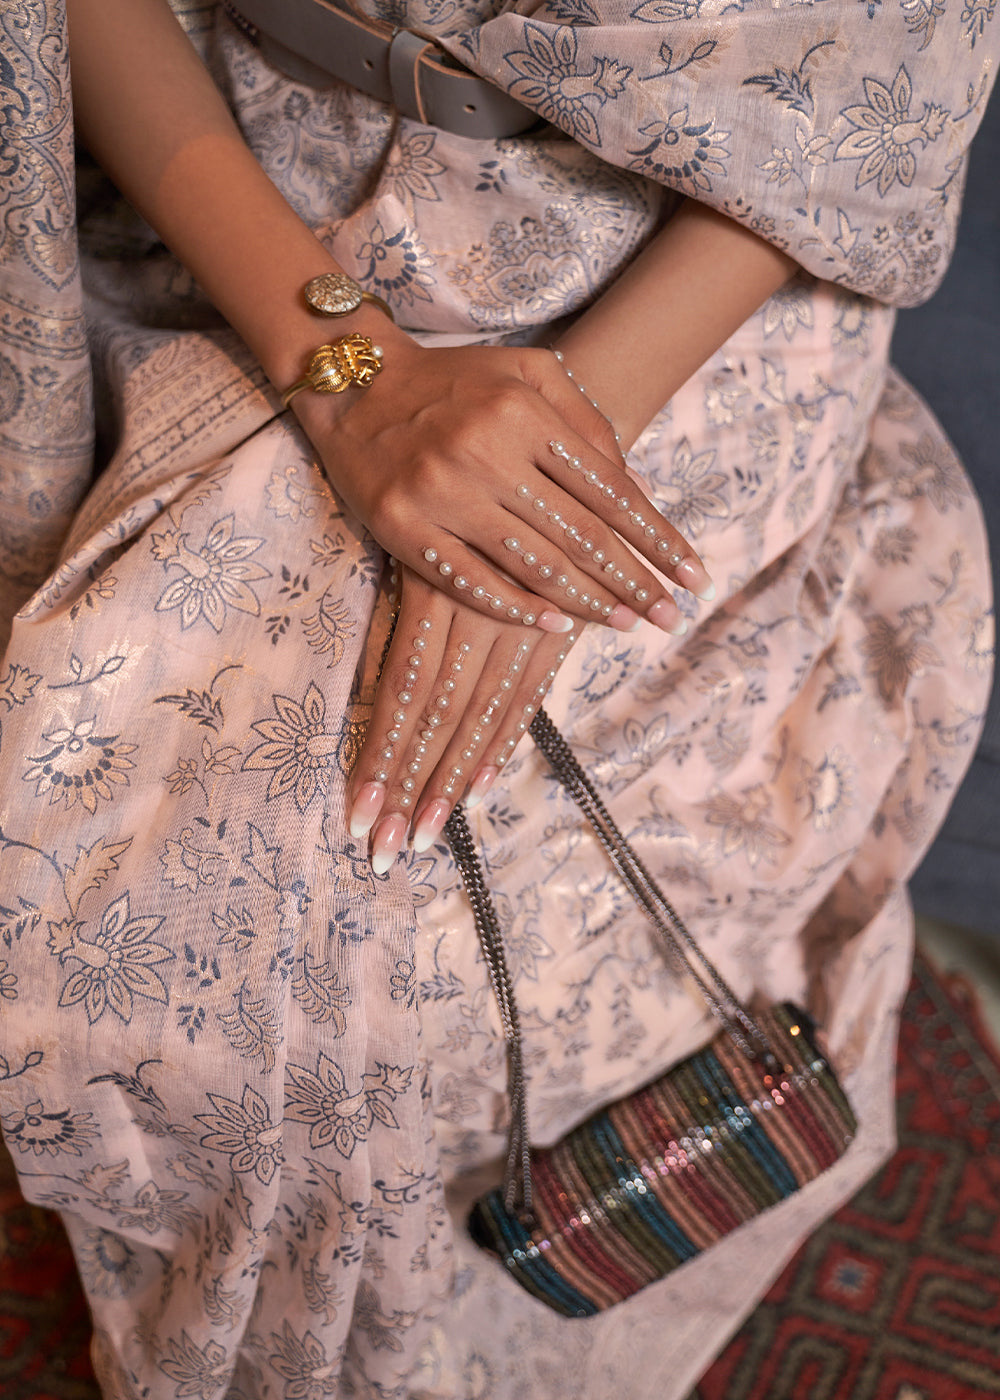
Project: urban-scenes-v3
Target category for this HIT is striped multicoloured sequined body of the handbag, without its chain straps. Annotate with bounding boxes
[469,1002,857,1317]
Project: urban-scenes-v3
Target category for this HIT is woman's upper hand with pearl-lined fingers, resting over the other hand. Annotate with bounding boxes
[294,338,714,634]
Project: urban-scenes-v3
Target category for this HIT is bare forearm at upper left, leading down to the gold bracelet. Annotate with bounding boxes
[67,0,402,388]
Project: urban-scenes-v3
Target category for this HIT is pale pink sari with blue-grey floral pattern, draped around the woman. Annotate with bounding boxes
[0,0,992,1400]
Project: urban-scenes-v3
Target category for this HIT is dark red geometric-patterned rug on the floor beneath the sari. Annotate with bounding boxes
[0,958,1000,1400]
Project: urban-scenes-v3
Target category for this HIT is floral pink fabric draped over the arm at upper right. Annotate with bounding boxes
[445,0,1000,307]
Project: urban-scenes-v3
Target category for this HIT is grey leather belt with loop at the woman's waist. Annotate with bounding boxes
[223,0,538,139]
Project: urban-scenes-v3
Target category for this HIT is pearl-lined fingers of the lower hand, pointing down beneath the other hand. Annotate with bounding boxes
[347,568,577,875]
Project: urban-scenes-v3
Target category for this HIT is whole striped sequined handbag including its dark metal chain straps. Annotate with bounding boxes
[445,711,857,1317]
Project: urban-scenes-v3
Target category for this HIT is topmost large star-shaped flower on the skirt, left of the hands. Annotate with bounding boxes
[153,515,270,631]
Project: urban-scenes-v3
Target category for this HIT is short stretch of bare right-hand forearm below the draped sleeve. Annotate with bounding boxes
[559,200,796,445]
